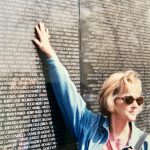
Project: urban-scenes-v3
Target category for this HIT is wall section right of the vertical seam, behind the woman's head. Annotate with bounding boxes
[80,0,150,132]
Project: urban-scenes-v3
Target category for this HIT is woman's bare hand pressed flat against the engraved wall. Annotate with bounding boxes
[33,22,56,58]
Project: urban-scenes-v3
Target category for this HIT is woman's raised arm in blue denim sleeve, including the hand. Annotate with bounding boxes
[33,23,94,140]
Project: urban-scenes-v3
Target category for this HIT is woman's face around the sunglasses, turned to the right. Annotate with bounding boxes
[114,92,142,121]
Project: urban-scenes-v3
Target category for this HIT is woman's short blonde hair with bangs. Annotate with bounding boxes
[99,70,142,116]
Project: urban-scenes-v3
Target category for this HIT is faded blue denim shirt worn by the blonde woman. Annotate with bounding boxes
[47,56,150,150]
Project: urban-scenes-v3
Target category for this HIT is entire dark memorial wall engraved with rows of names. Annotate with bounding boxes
[0,0,150,150]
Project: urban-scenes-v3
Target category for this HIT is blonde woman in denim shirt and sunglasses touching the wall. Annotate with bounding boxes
[33,23,150,150]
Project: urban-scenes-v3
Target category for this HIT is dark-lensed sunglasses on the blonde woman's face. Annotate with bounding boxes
[115,96,144,106]
